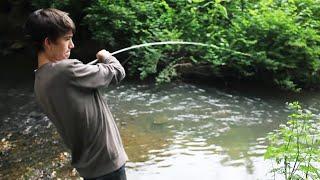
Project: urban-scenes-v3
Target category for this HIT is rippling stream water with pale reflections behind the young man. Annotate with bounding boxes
[0,83,320,180]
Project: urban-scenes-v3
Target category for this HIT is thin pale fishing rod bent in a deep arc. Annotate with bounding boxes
[88,41,251,65]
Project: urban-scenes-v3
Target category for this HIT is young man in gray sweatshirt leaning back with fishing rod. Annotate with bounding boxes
[25,9,127,180]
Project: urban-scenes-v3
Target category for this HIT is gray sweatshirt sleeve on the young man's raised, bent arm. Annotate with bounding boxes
[69,56,125,88]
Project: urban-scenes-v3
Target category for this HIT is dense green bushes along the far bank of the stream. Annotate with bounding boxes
[5,0,320,91]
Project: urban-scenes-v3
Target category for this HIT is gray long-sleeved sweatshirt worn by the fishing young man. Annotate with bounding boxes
[34,56,128,178]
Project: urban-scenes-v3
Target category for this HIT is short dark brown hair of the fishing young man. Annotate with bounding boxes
[25,8,76,53]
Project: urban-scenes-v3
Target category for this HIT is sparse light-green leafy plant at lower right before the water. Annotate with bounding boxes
[265,102,320,179]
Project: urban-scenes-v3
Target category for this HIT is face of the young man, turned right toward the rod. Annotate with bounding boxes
[47,31,74,61]
